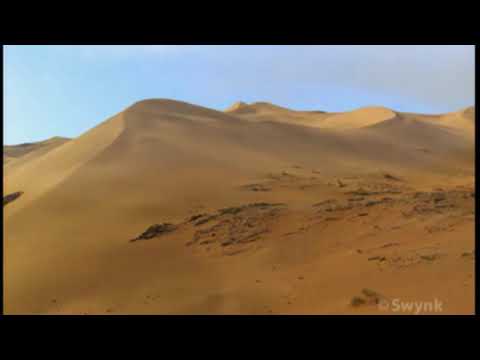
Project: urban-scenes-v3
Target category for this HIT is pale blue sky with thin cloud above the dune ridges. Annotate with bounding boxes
[4,45,475,144]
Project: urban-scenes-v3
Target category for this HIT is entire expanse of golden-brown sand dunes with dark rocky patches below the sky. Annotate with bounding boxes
[3,99,475,315]
